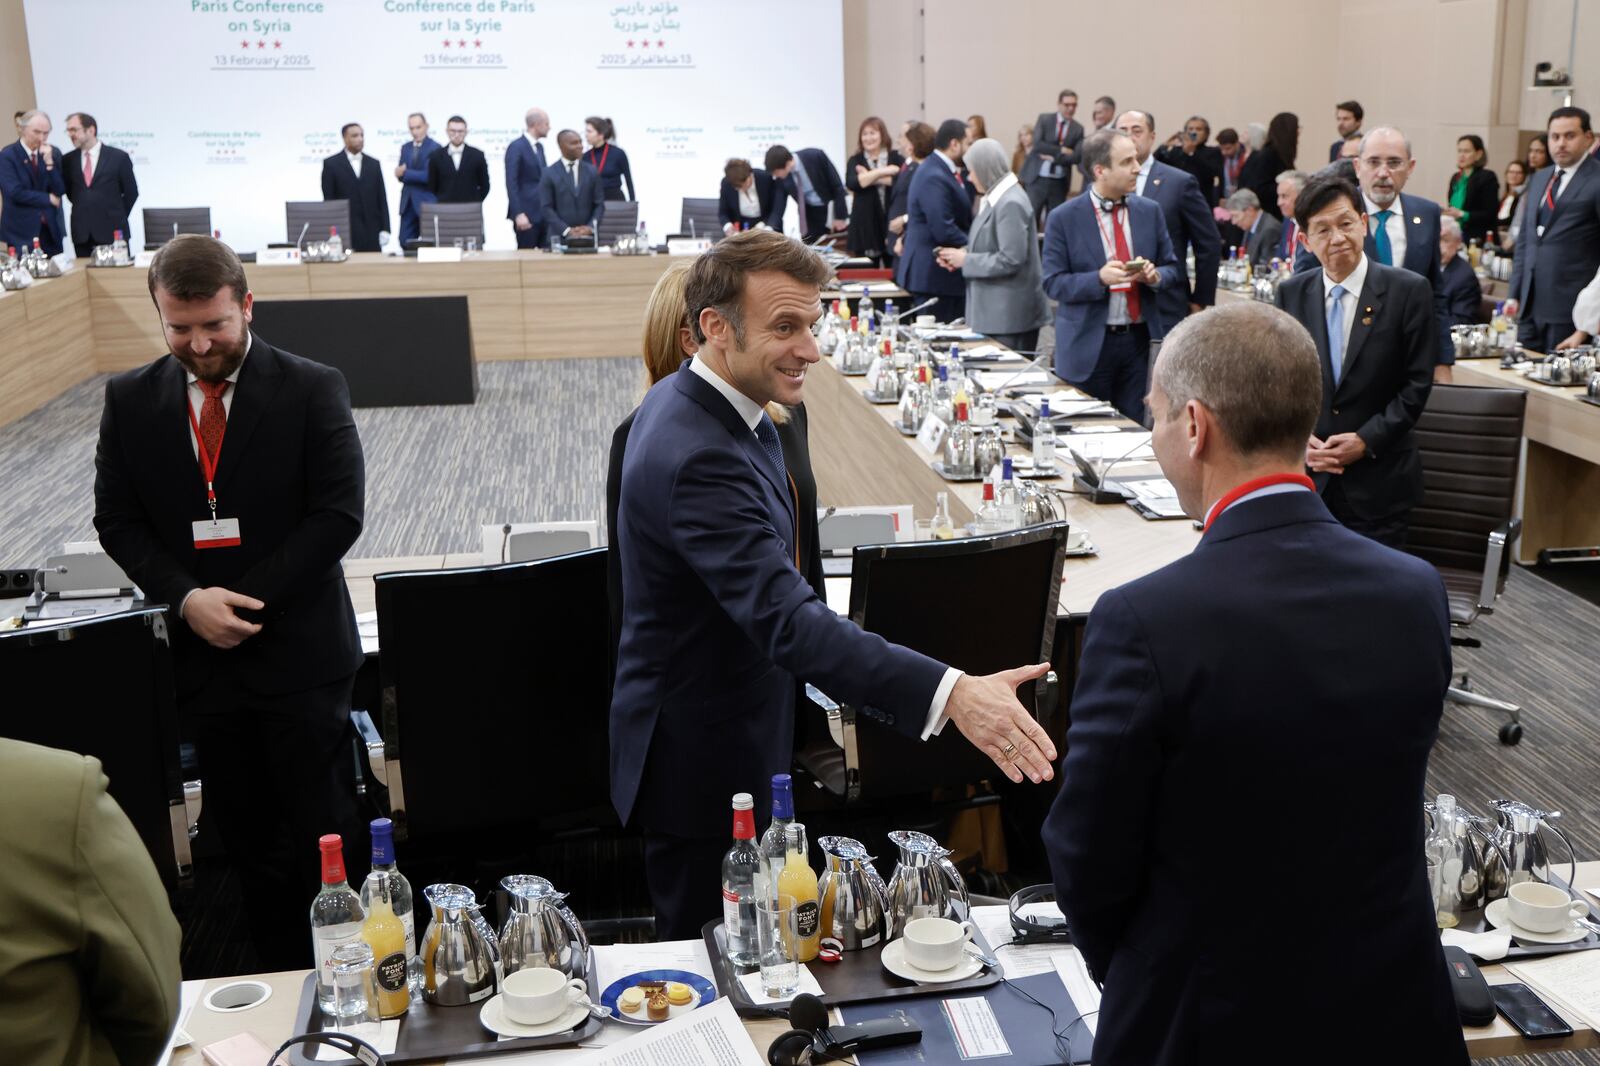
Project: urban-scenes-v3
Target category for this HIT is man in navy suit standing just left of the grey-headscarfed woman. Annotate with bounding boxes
[894,118,973,322]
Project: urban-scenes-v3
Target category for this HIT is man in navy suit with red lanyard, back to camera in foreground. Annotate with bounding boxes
[1042,300,1467,1066]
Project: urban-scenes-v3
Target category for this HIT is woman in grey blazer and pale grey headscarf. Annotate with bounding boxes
[939,138,1050,352]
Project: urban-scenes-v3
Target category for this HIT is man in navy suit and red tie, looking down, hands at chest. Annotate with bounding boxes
[1043,128,1184,423]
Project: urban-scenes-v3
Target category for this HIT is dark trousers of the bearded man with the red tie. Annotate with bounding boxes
[181,675,368,970]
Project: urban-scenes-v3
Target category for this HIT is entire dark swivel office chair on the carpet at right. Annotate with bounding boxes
[1406,384,1528,744]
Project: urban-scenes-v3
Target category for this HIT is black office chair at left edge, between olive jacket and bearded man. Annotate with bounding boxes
[0,607,194,890]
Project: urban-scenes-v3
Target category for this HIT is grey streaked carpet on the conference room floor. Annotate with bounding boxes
[0,359,1600,1066]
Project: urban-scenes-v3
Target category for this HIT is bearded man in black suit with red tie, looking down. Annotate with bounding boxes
[94,234,366,970]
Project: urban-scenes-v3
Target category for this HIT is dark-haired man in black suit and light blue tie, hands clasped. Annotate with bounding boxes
[1277,178,1438,547]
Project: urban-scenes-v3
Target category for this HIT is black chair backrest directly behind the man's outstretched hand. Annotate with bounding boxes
[845,522,1067,800]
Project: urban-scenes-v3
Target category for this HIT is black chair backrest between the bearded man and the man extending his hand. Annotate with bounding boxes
[374,547,614,853]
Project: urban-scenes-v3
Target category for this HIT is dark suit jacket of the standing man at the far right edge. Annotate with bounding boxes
[1510,155,1600,331]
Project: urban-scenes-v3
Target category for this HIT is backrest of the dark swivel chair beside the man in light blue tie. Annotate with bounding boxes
[1406,384,1528,571]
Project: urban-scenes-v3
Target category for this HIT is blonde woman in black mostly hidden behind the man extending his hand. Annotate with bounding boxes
[605,259,827,669]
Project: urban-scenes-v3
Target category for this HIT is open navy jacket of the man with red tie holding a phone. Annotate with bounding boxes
[1043,194,1187,381]
